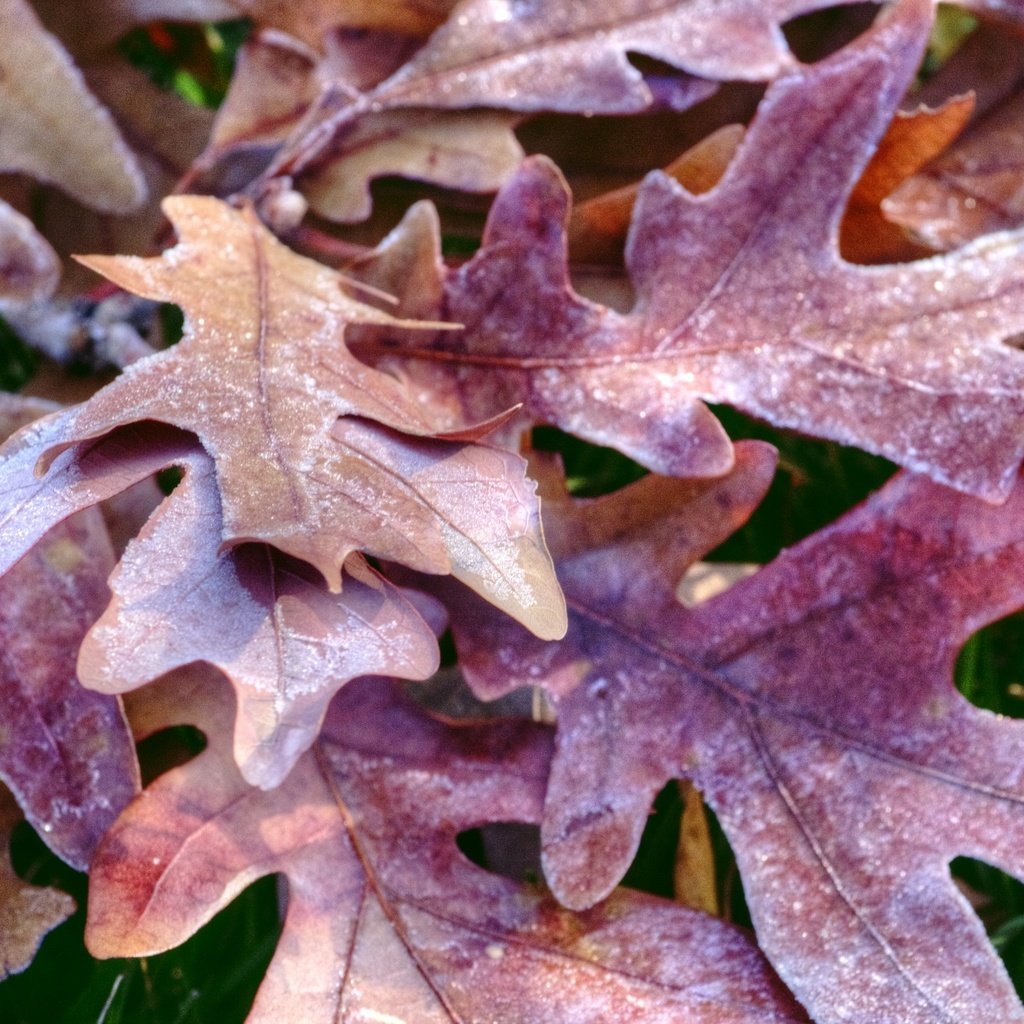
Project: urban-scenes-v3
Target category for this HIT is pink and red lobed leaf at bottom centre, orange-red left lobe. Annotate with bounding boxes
[87,667,805,1024]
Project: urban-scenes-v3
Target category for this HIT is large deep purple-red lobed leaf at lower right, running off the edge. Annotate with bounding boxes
[444,448,1024,1024]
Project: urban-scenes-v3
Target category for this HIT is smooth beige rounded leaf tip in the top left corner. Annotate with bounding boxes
[0,0,145,213]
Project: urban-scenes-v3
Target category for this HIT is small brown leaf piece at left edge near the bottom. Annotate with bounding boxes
[0,785,75,981]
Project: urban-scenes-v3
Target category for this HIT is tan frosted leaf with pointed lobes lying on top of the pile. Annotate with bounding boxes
[22,197,564,636]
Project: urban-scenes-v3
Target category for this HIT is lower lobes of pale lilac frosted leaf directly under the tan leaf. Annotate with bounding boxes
[79,444,437,788]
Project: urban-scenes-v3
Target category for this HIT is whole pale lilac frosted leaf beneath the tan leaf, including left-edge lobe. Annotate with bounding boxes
[0,414,444,787]
